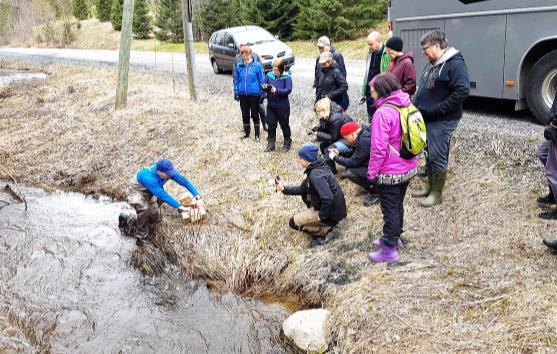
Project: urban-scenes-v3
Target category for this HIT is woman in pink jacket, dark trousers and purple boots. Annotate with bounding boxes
[367,73,418,262]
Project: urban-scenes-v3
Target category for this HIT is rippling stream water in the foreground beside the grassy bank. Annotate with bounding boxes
[0,187,287,353]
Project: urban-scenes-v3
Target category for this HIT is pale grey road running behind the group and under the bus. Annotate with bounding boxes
[0,48,543,138]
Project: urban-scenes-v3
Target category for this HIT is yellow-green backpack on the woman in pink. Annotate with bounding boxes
[385,103,427,160]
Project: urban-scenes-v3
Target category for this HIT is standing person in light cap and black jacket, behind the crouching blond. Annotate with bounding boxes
[315,52,350,110]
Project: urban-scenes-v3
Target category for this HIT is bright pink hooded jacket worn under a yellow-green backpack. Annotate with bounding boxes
[367,90,418,180]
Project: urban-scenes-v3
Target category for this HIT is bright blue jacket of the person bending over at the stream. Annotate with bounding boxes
[136,165,199,208]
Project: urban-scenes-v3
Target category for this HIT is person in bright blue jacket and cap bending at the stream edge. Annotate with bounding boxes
[118,160,204,246]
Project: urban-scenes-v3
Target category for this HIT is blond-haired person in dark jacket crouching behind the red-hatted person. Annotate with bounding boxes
[312,98,353,174]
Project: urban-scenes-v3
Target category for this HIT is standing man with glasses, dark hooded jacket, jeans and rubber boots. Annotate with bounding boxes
[413,31,470,207]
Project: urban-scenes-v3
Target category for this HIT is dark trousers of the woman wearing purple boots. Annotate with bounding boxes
[377,182,408,247]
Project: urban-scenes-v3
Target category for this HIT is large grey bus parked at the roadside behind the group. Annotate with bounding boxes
[388,0,557,124]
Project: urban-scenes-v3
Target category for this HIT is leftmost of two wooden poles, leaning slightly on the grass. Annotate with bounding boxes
[116,0,134,109]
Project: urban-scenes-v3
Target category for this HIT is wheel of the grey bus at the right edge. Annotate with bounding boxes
[526,50,557,124]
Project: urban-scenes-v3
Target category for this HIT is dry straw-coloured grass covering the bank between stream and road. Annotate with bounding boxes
[0,63,557,353]
